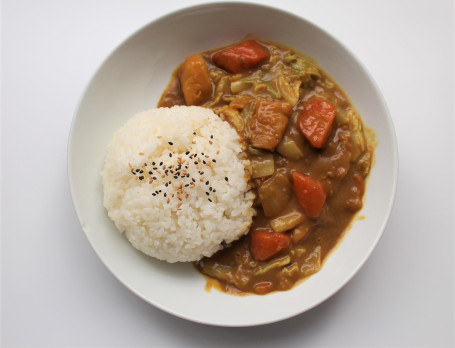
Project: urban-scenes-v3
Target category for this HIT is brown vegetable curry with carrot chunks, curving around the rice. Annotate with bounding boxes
[158,39,373,294]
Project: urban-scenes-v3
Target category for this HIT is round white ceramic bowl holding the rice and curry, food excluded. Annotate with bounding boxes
[68,3,398,326]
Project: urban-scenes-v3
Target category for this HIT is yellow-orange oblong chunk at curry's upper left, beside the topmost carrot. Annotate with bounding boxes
[179,54,212,105]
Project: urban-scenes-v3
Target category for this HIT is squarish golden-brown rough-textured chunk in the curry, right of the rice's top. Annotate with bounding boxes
[250,100,292,151]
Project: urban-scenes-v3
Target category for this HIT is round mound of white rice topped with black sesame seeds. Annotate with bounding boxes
[101,106,255,262]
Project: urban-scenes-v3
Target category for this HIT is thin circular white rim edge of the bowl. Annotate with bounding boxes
[67,1,399,327]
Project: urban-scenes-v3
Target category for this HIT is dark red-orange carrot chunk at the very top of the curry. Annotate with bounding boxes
[212,39,270,74]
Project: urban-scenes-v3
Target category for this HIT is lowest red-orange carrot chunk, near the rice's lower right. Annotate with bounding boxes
[250,228,292,261]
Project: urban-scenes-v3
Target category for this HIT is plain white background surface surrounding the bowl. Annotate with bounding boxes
[1,0,455,348]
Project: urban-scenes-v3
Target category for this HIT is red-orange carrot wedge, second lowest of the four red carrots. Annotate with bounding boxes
[292,172,327,218]
